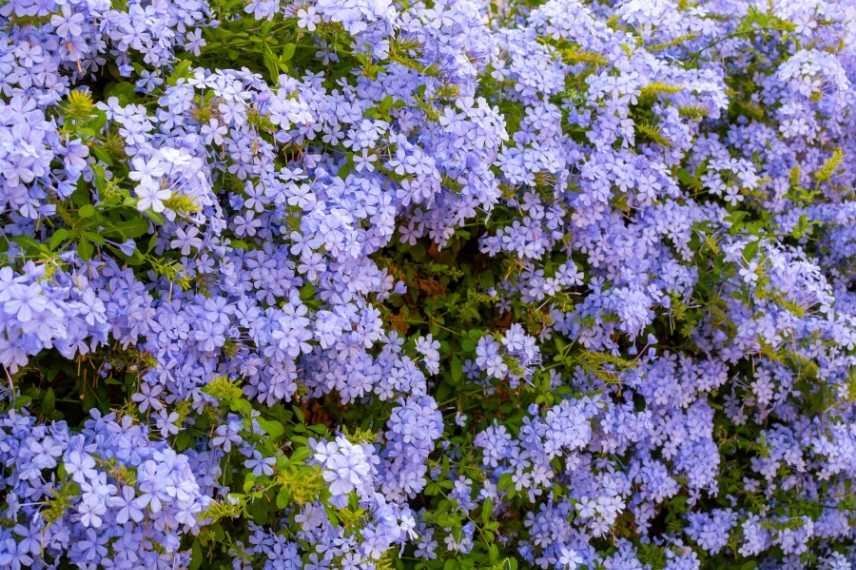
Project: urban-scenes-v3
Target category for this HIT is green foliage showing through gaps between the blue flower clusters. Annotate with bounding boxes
[5,0,856,570]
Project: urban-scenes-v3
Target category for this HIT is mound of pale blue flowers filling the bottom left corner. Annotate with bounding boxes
[0,411,210,568]
